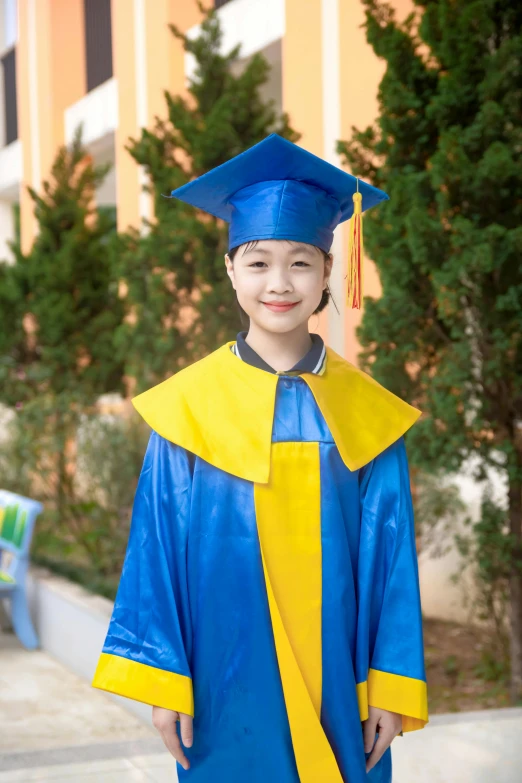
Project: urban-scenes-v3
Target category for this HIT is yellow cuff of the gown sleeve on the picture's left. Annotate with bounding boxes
[91,653,194,717]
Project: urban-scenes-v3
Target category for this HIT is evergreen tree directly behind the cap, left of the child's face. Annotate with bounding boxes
[117,4,299,392]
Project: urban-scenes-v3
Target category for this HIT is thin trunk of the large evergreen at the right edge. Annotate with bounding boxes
[509,470,522,704]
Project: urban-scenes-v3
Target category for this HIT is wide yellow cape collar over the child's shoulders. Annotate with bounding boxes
[132,340,421,484]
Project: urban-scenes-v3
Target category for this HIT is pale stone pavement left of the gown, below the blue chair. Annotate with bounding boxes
[0,631,177,783]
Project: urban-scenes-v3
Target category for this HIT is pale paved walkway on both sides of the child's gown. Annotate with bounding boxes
[0,632,522,783]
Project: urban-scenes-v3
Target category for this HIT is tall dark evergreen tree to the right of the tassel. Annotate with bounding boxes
[338,0,522,702]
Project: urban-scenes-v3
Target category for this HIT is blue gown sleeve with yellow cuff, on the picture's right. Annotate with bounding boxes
[358,436,428,732]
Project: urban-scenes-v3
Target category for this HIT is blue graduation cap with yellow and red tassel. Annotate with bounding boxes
[166,133,388,307]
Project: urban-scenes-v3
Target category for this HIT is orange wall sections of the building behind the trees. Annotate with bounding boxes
[17,0,412,361]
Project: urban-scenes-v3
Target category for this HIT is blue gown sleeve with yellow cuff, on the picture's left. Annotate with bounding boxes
[91,430,194,715]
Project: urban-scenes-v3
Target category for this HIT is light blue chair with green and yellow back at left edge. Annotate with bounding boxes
[0,489,43,650]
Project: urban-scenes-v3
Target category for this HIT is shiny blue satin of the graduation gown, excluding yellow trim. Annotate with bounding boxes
[93,376,425,783]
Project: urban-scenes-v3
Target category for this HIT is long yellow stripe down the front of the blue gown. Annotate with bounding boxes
[254,442,342,783]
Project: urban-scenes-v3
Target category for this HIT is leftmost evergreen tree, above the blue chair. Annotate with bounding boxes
[0,127,124,522]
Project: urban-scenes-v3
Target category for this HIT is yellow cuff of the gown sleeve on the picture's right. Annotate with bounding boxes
[357,669,429,731]
